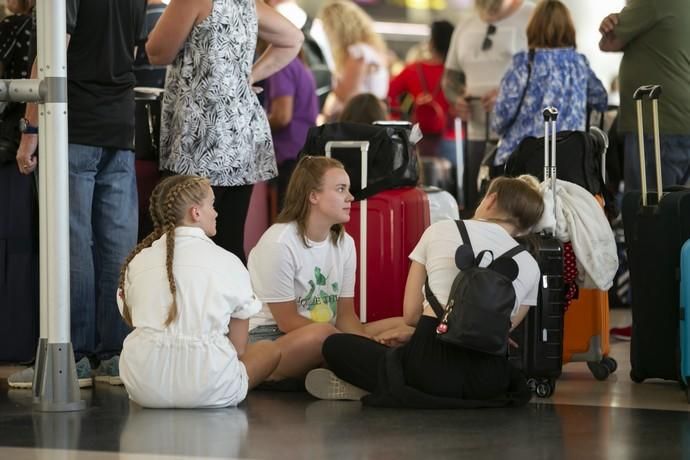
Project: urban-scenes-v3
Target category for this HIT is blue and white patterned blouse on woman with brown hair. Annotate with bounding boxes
[491,48,608,165]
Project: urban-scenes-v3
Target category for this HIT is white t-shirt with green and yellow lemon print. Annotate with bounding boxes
[247,222,356,330]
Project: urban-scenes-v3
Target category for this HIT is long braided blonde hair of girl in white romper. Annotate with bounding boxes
[119,176,211,326]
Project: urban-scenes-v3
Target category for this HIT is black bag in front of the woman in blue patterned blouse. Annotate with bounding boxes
[505,129,608,195]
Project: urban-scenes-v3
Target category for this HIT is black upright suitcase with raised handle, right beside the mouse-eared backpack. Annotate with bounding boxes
[509,108,565,398]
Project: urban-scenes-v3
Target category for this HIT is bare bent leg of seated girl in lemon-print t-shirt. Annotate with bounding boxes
[269,323,338,380]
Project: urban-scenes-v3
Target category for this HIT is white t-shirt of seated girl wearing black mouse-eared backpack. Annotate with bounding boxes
[410,220,540,316]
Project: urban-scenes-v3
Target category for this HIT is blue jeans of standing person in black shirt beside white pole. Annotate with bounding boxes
[69,144,138,360]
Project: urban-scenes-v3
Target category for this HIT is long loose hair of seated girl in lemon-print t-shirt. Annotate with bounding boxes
[276,156,345,247]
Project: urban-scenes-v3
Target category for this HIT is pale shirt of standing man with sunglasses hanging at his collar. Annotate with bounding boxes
[446,1,534,141]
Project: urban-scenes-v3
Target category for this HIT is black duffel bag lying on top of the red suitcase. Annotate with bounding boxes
[300,122,419,200]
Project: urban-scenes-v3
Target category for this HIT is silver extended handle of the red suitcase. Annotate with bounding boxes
[324,141,369,323]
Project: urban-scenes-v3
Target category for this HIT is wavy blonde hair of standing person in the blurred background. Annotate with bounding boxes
[318,0,388,71]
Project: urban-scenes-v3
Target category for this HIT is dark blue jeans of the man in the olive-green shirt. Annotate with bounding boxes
[623,133,690,191]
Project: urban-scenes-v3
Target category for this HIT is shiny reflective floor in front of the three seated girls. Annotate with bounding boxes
[0,311,690,460]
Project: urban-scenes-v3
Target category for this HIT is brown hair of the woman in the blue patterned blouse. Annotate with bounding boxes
[527,0,577,49]
